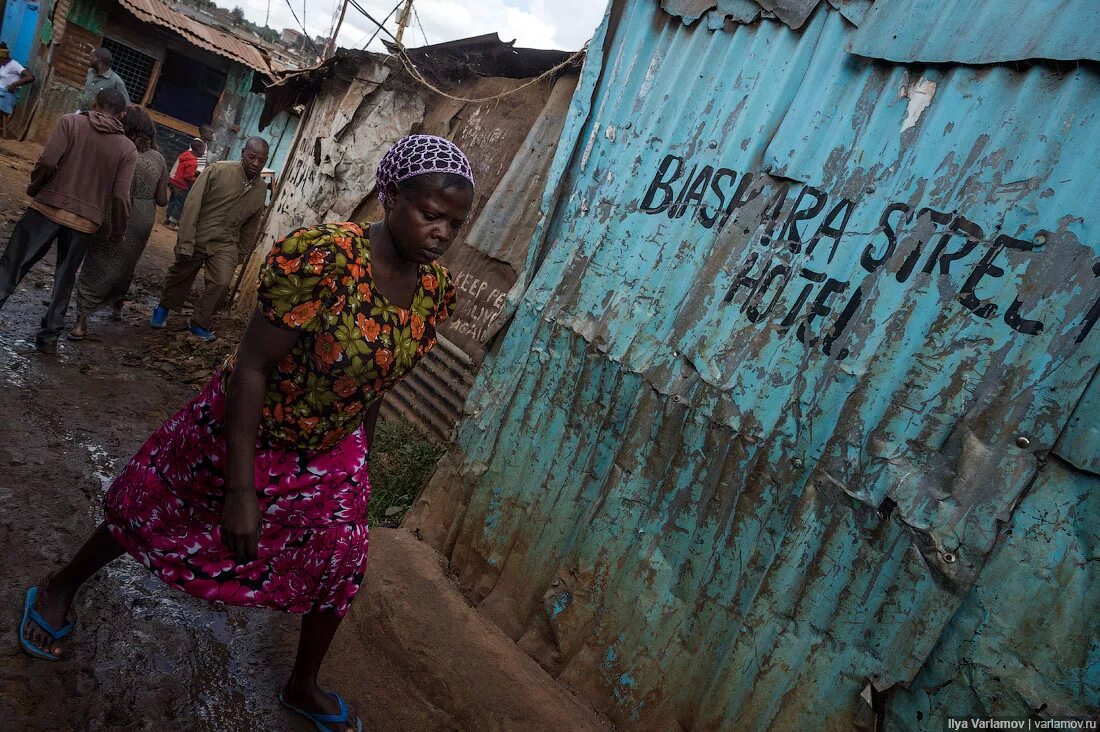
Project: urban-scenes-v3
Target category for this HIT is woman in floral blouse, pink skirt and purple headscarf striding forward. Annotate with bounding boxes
[20,135,473,730]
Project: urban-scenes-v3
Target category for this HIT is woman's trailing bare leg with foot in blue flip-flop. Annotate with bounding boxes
[24,524,122,656]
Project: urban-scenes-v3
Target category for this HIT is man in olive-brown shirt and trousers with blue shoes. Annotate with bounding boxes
[149,138,267,341]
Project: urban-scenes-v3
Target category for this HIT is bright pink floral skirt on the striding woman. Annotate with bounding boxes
[105,371,371,615]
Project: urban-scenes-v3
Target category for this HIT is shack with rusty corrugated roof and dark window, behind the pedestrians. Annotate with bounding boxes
[8,0,297,170]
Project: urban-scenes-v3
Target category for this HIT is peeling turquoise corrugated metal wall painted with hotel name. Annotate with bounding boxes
[405,0,1100,730]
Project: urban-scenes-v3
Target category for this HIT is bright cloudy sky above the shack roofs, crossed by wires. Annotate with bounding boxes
[216,0,606,51]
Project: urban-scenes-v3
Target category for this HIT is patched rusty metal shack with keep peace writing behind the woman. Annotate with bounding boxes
[237,34,581,439]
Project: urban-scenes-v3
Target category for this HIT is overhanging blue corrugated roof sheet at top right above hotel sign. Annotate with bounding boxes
[851,0,1100,64]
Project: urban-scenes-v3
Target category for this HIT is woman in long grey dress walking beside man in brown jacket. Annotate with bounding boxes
[69,106,168,340]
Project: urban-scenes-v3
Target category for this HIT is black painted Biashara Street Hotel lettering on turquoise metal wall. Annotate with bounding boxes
[639,154,1100,359]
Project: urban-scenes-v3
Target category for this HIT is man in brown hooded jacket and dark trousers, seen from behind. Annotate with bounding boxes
[0,88,138,352]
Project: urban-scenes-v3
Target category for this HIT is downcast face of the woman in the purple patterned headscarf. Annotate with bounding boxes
[386,182,474,264]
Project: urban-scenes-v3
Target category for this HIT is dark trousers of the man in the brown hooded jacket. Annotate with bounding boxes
[0,208,95,343]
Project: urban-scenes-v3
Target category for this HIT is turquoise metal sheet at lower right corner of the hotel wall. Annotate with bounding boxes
[886,460,1100,730]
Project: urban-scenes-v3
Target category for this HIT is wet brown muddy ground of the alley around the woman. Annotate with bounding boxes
[0,141,605,731]
